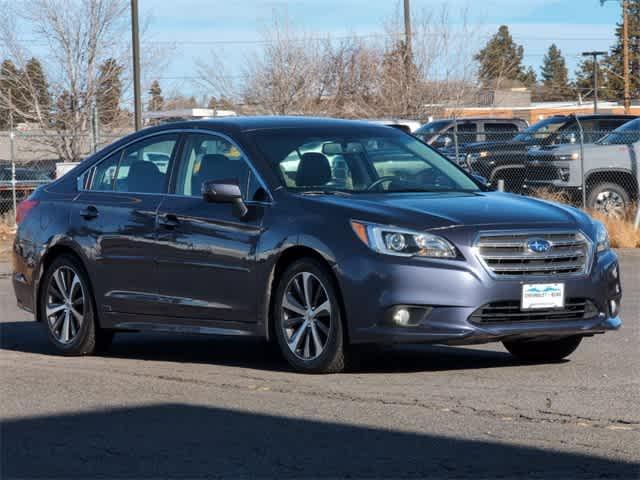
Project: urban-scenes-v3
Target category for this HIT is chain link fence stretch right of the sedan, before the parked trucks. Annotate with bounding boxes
[431,129,640,224]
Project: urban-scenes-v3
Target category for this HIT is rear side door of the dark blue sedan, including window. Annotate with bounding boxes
[72,134,178,323]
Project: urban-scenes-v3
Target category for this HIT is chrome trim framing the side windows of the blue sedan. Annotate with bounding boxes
[78,128,274,205]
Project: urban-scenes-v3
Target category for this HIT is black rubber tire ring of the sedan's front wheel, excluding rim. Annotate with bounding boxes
[271,259,344,373]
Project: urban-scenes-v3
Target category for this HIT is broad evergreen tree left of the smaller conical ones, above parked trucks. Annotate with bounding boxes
[474,25,527,87]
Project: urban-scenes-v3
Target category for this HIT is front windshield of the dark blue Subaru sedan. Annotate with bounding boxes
[253,128,479,193]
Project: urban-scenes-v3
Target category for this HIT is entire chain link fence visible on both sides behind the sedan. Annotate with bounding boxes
[0,124,640,228]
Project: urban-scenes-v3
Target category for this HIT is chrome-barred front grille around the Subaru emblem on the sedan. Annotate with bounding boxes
[475,232,590,277]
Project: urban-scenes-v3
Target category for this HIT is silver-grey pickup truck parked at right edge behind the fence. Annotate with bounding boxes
[525,118,640,217]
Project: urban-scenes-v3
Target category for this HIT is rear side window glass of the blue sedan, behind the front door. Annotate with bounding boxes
[90,135,178,193]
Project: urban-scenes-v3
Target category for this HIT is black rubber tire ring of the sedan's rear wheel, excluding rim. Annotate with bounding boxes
[38,254,96,355]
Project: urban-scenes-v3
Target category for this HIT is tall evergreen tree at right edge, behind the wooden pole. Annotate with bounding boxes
[603,0,640,101]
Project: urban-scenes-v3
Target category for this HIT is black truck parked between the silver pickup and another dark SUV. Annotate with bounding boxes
[464,114,636,193]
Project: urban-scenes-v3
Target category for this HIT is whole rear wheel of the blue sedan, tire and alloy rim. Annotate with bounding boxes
[38,254,113,356]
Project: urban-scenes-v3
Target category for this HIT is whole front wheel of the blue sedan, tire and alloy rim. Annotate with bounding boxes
[271,258,345,373]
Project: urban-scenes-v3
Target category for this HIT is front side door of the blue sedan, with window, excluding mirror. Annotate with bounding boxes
[158,133,266,323]
